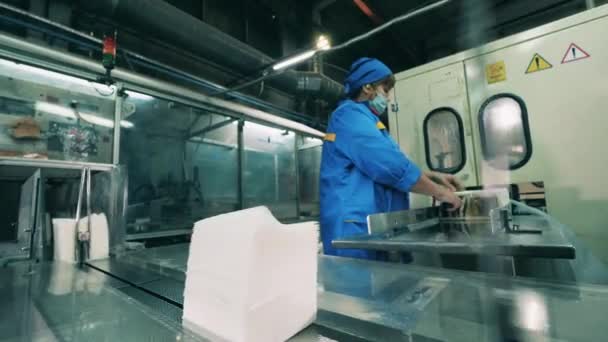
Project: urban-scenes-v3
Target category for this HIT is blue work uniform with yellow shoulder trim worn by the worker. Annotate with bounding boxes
[320,100,421,259]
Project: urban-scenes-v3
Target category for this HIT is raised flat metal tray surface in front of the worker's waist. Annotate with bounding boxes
[332,216,575,259]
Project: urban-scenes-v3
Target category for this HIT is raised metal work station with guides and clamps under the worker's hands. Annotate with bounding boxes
[332,189,592,284]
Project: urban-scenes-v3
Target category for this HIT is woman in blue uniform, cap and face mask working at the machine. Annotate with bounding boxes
[320,58,461,259]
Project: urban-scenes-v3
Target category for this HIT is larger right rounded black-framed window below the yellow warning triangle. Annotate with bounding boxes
[479,94,532,170]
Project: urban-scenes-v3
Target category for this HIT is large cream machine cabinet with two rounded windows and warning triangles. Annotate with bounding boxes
[389,6,608,262]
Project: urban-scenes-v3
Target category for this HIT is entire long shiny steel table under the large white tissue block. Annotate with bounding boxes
[0,245,608,342]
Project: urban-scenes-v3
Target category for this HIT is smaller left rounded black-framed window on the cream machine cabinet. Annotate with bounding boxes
[424,107,466,173]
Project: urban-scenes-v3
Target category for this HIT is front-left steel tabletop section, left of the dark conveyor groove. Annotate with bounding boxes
[0,263,201,341]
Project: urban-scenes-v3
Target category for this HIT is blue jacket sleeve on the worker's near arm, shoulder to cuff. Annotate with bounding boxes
[333,111,422,192]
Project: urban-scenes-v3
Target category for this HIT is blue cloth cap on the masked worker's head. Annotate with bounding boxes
[344,57,393,95]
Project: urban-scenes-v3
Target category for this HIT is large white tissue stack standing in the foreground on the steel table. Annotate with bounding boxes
[183,207,318,342]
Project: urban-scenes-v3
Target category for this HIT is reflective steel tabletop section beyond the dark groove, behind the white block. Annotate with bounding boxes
[109,244,608,341]
